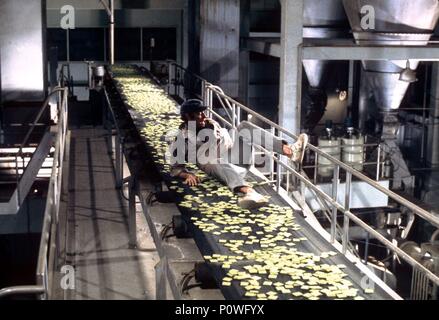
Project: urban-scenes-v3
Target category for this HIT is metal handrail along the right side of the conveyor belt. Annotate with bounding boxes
[166,62,439,284]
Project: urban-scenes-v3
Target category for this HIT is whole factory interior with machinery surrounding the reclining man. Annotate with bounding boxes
[0,0,439,301]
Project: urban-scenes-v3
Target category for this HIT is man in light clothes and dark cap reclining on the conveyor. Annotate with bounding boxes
[170,99,308,209]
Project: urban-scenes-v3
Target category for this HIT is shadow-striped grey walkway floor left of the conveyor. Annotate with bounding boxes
[65,128,159,300]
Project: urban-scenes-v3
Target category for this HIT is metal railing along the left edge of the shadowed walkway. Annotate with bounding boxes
[0,88,68,299]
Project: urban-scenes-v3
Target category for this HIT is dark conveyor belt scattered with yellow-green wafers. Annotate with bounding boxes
[105,66,396,299]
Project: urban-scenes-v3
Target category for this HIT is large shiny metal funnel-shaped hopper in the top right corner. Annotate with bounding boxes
[343,0,439,111]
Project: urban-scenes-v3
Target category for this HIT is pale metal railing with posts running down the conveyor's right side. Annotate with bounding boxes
[169,62,439,284]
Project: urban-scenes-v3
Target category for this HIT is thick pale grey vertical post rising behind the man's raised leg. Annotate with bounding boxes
[279,0,304,134]
